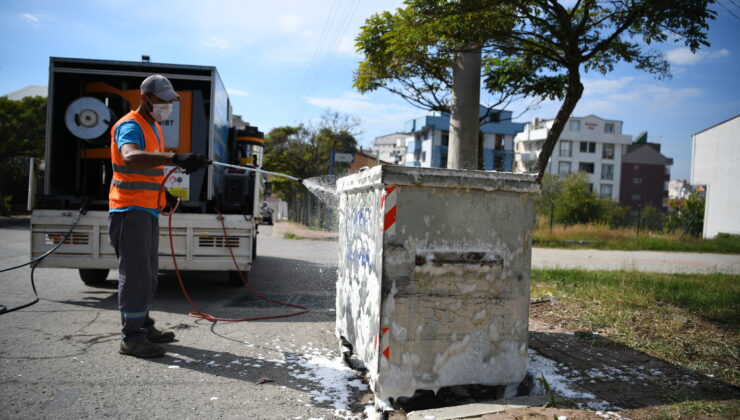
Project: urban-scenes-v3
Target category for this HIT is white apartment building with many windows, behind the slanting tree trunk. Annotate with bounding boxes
[514,115,632,201]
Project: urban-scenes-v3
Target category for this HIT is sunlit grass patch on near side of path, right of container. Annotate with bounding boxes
[531,269,740,386]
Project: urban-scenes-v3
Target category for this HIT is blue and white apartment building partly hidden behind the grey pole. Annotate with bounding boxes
[404,106,524,172]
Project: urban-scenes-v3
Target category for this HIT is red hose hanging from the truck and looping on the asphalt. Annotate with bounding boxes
[159,167,308,322]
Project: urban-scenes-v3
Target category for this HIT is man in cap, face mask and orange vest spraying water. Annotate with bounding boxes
[108,75,210,357]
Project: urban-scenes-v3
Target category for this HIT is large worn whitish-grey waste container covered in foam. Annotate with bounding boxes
[336,166,539,406]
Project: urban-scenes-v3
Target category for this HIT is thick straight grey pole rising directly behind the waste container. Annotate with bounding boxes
[447,49,482,169]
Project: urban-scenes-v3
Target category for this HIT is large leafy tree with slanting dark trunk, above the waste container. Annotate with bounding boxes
[355,0,716,182]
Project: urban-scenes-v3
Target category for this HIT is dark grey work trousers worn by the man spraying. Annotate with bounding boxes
[108,210,159,342]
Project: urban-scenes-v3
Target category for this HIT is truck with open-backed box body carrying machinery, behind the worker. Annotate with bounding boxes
[29,57,264,284]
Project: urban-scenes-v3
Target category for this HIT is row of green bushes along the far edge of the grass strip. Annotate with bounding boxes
[535,172,704,237]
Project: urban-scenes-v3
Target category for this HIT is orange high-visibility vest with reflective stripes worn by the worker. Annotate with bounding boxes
[108,111,165,209]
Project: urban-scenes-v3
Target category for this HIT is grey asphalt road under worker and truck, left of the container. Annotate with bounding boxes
[0,226,367,419]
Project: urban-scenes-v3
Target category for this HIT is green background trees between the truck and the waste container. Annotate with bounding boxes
[263,111,359,199]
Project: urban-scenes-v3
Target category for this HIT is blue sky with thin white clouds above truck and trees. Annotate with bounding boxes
[0,0,740,179]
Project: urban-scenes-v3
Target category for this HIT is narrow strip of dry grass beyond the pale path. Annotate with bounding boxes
[533,223,740,254]
